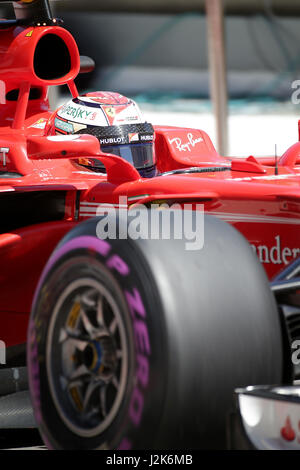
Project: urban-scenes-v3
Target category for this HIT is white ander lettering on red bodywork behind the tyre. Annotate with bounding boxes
[251,235,300,264]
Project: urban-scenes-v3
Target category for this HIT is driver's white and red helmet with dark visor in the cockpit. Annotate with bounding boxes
[53,92,156,178]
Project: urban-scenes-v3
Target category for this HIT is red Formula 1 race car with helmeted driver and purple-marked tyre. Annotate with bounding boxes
[0,0,300,449]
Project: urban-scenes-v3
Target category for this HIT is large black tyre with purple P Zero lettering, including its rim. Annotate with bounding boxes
[27,215,283,449]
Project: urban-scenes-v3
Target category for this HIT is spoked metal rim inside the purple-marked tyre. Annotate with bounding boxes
[46,278,128,437]
